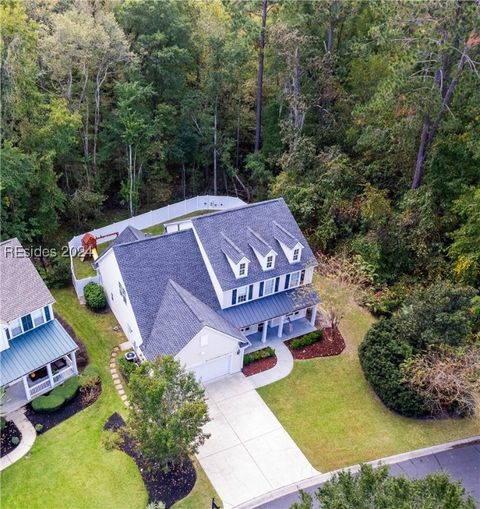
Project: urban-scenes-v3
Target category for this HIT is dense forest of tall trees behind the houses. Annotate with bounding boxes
[1,0,480,292]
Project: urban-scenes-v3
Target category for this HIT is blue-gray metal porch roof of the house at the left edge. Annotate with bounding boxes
[0,320,78,387]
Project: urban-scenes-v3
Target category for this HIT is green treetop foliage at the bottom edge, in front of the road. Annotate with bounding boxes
[290,465,475,509]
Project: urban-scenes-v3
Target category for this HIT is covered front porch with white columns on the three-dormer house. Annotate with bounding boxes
[245,305,317,353]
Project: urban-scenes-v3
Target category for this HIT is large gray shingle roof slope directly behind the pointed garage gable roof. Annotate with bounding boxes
[113,230,218,341]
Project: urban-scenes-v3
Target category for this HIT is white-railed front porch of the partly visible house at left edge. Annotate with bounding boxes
[0,352,78,415]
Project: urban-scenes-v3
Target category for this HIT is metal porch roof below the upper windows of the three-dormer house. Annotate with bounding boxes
[219,285,320,328]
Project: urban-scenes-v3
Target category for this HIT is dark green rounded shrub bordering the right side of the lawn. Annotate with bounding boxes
[359,318,430,417]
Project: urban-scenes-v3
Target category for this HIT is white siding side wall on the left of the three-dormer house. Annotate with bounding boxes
[99,249,143,346]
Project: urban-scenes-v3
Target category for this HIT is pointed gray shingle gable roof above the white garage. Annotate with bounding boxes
[141,280,248,360]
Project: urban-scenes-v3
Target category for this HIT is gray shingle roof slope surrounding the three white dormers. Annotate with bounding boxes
[192,198,317,291]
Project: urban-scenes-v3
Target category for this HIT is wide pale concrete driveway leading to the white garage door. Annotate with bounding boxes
[197,373,318,509]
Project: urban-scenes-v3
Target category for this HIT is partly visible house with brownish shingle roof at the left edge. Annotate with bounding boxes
[0,239,78,415]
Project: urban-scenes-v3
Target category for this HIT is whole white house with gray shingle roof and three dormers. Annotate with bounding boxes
[96,199,320,381]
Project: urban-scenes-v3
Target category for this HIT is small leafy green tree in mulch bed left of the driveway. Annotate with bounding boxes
[128,356,209,471]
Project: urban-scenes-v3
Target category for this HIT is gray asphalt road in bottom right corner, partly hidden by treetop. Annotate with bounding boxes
[257,442,480,509]
